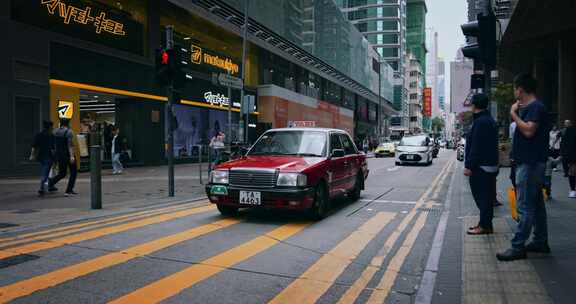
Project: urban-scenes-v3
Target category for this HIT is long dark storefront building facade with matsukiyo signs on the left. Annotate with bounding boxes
[0,0,396,176]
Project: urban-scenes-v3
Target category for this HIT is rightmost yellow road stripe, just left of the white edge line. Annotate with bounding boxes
[367,212,428,303]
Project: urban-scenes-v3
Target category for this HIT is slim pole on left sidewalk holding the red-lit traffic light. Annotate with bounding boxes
[166,25,174,197]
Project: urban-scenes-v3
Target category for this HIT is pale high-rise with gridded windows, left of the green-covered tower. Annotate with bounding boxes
[335,0,408,127]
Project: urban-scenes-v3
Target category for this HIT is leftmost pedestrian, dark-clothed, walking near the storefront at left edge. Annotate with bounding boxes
[30,121,54,196]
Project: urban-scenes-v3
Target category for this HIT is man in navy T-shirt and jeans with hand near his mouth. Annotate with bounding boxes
[496,74,550,261]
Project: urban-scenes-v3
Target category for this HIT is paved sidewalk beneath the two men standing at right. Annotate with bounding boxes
[433,163,576,304]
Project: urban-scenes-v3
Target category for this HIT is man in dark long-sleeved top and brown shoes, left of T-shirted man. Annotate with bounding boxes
[464,94,498,235]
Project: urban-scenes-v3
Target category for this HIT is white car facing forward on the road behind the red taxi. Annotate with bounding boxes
[396,135,434,165]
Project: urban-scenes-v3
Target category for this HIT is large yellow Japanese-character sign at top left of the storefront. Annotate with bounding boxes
[40,0,126,36]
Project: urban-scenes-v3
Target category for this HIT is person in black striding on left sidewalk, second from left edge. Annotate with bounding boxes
[48,118,78,196]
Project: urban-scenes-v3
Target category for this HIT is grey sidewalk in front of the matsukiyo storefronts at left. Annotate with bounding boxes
[0,164,208,232]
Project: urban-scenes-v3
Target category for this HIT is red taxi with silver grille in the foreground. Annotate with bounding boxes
[206,128,368,219]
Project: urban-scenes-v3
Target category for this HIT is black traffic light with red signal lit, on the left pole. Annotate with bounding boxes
[156,45,188,88]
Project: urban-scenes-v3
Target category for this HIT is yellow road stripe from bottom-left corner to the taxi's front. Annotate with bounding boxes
[0,219,240,303]
